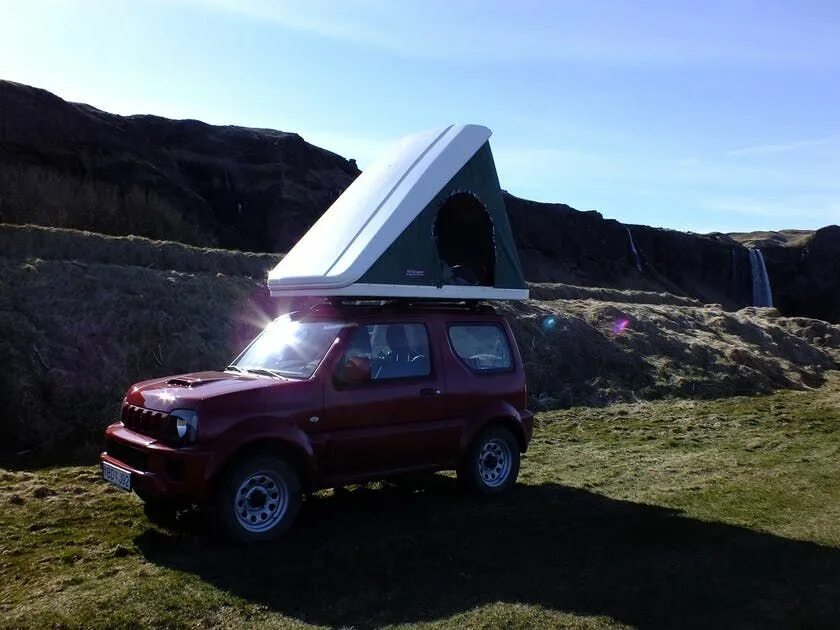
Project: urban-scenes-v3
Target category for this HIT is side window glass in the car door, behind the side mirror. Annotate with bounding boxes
[337,324,432,384]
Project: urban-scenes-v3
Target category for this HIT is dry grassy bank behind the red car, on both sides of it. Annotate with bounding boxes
[0,226,840,461]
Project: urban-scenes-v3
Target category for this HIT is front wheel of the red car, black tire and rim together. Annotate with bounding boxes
[215,454,302,543]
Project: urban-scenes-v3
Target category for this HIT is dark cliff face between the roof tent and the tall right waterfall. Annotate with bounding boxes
[505,195,752,308]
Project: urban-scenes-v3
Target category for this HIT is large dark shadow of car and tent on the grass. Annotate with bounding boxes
[135,476,840,627]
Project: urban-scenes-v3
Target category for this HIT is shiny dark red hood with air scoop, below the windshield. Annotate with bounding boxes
[126,372,282,413]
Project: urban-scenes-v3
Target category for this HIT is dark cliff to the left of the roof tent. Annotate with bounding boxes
[0,82,359,251]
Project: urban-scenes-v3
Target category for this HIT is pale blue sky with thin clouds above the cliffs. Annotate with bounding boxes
[0,0,840,232]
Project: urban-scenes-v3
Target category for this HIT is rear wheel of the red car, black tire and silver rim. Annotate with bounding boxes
[458,427,519,495]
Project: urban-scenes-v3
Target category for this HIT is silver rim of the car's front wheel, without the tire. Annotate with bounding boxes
[233,472,289,534]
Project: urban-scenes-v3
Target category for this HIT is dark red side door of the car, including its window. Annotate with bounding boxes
[323,319,458,477]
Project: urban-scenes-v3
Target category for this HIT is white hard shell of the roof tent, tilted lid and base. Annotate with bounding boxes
[268,125,528,299]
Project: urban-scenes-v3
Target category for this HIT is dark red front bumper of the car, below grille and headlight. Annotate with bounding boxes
[99,422,213,503]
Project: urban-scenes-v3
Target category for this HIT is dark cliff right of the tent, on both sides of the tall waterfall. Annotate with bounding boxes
[505,194,840,322]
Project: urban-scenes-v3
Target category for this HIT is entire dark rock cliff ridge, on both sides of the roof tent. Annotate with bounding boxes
[0,81,840,322]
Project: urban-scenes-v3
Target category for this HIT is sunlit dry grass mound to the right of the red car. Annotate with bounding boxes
[502,300,840,408]
